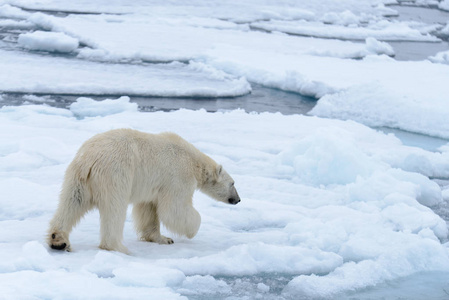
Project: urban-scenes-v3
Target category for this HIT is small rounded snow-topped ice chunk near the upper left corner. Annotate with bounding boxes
[18,31,79,53]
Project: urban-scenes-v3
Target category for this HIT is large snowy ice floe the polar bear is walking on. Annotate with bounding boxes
[0,98,449,299]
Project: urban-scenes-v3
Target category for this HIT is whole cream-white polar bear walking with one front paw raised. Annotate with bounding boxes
[47,129,240,253]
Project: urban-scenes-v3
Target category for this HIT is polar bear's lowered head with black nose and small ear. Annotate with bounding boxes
[201,165,240,205]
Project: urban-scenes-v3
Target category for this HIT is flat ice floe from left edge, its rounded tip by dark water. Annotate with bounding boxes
[0,50,251,97]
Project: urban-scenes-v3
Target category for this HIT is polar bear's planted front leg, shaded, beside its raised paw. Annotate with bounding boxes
[133,202,173,244]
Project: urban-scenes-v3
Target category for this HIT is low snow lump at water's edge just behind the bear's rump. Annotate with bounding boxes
[70,96,137,118]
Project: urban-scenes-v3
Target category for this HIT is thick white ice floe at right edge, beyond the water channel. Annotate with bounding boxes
[310,57,449,138]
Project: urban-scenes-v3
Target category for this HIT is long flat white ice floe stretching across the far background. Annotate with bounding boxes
[25,12,396,62]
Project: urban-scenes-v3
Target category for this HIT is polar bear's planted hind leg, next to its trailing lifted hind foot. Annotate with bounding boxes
[98,199,129,254]
